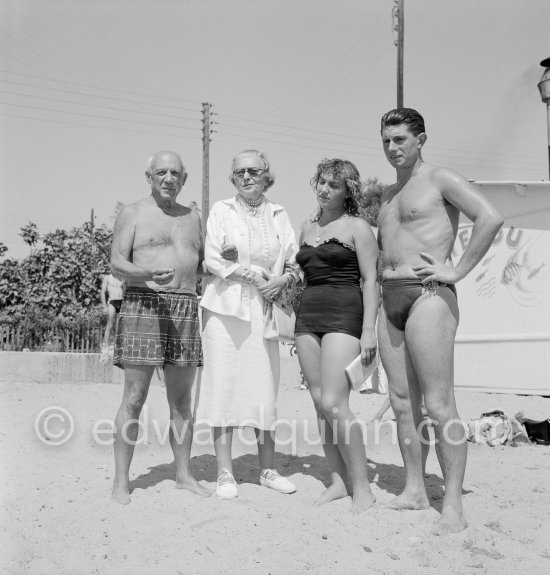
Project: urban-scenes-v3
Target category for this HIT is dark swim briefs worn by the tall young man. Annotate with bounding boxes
[382,279,456,331]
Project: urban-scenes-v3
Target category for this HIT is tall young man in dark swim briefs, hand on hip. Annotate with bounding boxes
[378,108,502,534]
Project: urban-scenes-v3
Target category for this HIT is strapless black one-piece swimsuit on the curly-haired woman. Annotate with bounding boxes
[296,238,363,339]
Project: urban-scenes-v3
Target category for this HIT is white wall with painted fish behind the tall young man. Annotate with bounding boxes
[453,182,550,395]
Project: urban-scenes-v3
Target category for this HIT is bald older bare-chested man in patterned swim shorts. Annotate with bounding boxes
[111,152,210,504]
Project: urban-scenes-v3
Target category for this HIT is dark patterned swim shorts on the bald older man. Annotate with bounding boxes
[113,286,202,369]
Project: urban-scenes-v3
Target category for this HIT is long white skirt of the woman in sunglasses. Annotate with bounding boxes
[196,289,280,429]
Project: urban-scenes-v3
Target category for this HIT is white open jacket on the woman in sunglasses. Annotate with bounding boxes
[200,196,298,321]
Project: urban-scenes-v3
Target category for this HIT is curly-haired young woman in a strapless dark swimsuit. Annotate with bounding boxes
[296,159,378,513]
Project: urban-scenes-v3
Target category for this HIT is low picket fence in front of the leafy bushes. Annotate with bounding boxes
[0,322,105,353]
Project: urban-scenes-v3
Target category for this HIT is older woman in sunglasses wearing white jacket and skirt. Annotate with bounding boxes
[197,150,298,499]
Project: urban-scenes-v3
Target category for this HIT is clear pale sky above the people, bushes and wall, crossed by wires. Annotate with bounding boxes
[0,0,550,257]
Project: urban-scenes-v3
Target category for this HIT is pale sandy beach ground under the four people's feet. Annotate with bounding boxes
[0,358,550,575]
